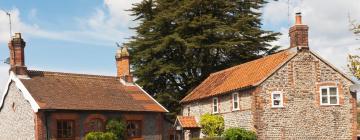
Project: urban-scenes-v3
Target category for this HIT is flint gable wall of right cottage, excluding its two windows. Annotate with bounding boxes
[255,51,356,140]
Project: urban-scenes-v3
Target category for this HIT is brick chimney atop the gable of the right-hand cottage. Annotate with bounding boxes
[289,13,309,50]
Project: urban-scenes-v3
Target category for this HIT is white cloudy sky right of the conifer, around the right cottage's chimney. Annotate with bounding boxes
[263,0,360,74]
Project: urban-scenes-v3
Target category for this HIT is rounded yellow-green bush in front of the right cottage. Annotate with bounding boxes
[200,113,225,137]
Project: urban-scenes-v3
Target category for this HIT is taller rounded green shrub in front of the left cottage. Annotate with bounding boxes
[106,120,126,139]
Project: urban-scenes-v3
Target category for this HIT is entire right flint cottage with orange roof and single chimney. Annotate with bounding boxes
[177,13,357,140]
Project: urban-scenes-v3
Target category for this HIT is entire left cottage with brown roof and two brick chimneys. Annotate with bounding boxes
[0,33,169,140]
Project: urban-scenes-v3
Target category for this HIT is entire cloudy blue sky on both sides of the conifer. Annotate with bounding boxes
[0,0,360,90]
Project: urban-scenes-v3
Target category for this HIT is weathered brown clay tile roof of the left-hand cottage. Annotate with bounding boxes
[21,70,166,112]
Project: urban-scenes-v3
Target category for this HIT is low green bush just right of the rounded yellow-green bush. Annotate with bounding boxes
[224,128,256,140]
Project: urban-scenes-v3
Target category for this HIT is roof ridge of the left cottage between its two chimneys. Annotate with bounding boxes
[27,70,117,79]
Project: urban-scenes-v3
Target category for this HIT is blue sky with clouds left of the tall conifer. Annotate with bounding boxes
[0,0,139,75]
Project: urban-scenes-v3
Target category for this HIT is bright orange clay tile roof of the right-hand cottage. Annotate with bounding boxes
[181,49,296,103]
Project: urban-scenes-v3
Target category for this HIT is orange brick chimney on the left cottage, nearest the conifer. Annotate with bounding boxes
[115,46,133,83]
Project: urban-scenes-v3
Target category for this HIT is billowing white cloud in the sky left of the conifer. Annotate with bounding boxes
[0,0,141,45]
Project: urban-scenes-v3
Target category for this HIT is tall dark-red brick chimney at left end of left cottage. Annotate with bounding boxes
[8,33,27,76]
